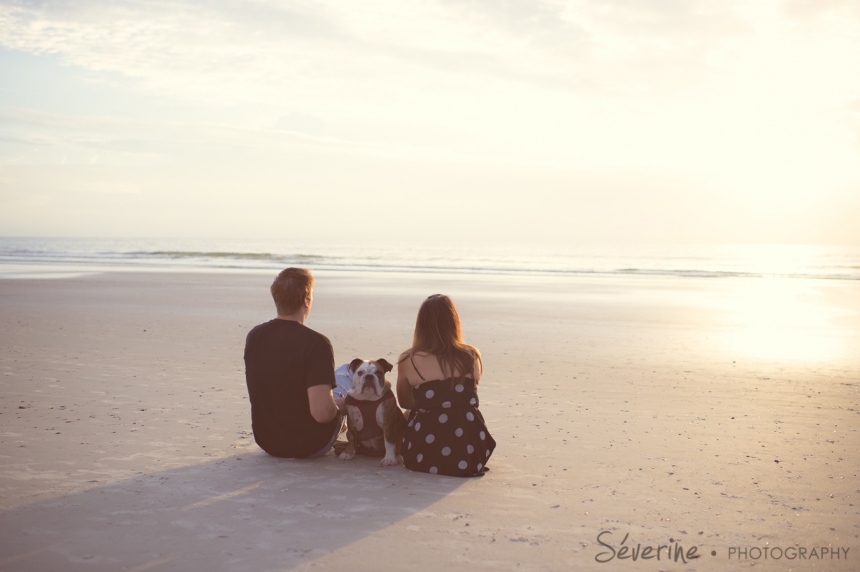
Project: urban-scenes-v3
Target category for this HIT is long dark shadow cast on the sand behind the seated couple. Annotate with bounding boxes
[0,450,466,572]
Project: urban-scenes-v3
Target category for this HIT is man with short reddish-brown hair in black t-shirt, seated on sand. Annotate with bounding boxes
[245,268,342,458]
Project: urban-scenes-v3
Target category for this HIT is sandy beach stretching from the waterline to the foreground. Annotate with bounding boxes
[0,273,860,571]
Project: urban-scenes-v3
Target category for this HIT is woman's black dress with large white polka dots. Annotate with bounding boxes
[401,377,496,477]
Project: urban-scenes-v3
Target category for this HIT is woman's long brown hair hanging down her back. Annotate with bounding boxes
[410,294,481,384]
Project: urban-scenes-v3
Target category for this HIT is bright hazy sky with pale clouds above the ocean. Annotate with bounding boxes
[0,0,860,246]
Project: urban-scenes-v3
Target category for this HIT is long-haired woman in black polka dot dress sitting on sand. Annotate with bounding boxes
[397,294,496,477]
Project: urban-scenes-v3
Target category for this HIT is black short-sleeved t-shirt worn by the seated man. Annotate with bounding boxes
[245,319,338,457]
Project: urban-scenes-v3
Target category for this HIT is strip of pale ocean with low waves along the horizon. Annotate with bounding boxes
[0,237,860,280]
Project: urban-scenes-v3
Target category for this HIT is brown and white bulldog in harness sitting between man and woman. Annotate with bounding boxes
[340,358,406,466]
